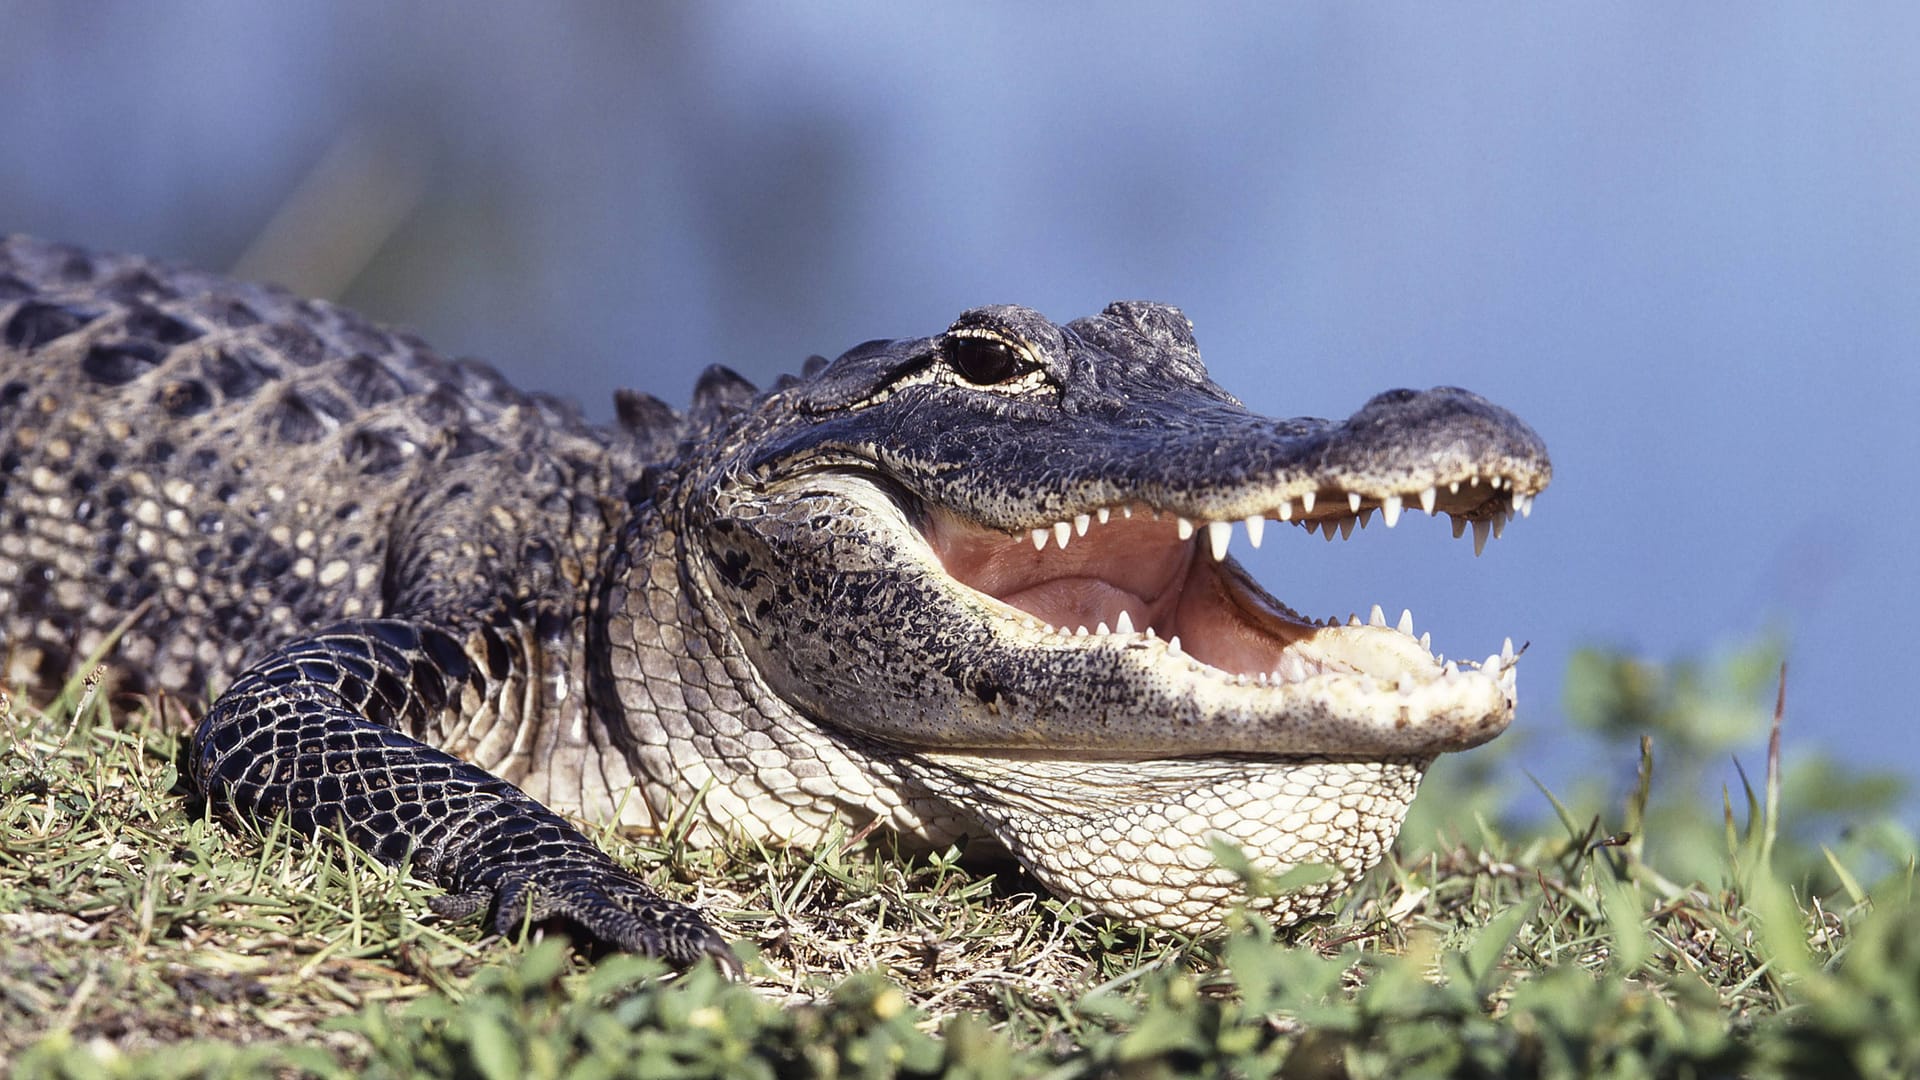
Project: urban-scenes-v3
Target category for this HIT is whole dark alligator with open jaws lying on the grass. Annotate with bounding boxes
[0,238,1551,970]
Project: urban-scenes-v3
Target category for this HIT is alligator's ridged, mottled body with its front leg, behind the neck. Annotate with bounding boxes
[0,240,732,961]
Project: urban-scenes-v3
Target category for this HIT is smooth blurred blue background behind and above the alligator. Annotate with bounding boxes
[0,2,1920,807]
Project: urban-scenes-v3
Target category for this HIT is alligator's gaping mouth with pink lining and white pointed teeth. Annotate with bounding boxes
[924,477,1536,718]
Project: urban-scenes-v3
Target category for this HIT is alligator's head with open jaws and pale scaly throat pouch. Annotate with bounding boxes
[645,304,1551,930]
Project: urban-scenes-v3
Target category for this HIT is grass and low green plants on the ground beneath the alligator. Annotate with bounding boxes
[0,634,1920,1078]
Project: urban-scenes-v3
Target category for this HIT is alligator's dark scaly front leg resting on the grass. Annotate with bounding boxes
[192,621,739,972]
